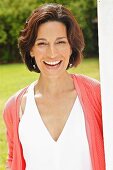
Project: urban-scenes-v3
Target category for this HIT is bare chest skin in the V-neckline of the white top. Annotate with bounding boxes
[35,91,76,141]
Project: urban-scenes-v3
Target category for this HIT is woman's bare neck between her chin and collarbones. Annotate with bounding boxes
[35,72,74,96]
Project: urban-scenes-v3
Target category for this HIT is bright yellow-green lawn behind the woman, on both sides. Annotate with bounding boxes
[0,58,99,170]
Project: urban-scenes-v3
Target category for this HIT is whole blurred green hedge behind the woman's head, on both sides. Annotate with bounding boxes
[0,0,98,63]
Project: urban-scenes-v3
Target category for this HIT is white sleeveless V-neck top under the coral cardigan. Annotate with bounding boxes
[18,83,92,170]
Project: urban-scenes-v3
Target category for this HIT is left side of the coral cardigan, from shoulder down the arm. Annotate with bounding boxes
[3,86,28,170]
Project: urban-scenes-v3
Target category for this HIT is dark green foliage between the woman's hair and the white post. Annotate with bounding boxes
[70,0,98,56]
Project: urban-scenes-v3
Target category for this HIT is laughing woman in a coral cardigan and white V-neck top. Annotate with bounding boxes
[4,4,105,170]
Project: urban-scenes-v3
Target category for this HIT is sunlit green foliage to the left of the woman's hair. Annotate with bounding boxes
[0,0,40,62]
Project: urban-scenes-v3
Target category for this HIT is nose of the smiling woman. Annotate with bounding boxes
[47,44,57,58]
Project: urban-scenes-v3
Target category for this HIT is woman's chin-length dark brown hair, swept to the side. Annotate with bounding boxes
[18,3,85,73]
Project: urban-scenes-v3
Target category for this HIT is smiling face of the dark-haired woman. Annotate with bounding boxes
[30,21,72,76]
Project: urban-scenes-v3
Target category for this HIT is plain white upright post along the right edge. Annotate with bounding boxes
[97,0,113,170]
